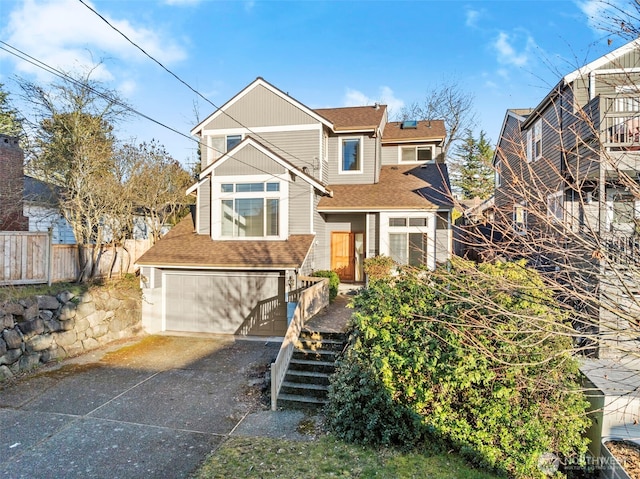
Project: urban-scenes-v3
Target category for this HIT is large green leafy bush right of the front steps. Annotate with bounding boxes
[327,260,588,477]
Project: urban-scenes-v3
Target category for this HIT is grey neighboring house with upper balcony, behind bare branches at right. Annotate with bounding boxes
[494,40,640,356]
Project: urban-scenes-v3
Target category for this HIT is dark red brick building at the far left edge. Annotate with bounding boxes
[0,135,29,231]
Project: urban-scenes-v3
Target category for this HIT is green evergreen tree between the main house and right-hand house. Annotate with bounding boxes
[453,129,494,199]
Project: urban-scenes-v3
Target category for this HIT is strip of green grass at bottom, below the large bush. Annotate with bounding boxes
[193,436,499,479]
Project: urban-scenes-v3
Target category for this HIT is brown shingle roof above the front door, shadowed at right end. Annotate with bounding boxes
[318,163,453,211]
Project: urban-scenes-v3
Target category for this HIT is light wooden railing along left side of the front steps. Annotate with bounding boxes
[271,276,329,411]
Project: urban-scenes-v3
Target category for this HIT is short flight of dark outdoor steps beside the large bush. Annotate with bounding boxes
[278,331,347,408]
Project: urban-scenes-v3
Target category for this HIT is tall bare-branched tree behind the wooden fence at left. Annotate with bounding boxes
[20,72,131,281]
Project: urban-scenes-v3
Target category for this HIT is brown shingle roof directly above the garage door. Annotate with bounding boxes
[136,215,314,269]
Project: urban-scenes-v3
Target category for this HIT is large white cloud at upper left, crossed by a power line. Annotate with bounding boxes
[2,0,186,80]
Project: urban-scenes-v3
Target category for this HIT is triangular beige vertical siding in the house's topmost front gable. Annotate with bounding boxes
[203,85,318,130]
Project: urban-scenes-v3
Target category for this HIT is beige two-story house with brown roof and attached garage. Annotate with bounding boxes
[138,78,452,335]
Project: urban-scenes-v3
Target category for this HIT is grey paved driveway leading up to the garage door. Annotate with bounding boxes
[0,336,280,478]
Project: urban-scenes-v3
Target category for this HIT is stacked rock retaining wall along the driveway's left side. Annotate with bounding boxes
[0,288,142,381]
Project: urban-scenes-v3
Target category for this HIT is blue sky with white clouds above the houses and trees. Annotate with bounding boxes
[0,0,630,170]
